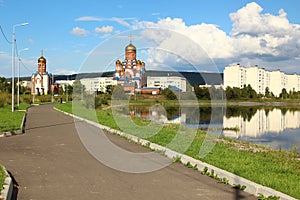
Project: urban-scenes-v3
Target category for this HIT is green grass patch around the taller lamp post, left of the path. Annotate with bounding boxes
[0,103,29,132]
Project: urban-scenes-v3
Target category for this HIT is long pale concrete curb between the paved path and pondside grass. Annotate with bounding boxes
[54,107,296,200]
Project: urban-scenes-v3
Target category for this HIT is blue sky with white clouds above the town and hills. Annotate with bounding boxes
[0,0,300,77]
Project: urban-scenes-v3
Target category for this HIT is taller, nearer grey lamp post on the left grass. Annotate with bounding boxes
[11,22,29,112]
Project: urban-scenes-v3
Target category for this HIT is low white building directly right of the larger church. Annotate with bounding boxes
[147,76,186,92]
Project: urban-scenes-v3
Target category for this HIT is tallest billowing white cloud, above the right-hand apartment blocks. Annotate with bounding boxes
[230,2,300,60]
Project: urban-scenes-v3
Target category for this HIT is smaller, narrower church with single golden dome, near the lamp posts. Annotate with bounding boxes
[30,52,51,95]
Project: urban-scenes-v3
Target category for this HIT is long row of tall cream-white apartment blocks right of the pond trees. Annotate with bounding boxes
[224,64,300,97]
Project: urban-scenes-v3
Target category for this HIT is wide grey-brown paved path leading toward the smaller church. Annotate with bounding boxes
[0,105,256,200]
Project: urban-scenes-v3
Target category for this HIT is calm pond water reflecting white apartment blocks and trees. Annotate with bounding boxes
[126,106,300,152]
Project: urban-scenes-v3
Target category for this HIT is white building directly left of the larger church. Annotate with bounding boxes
[80,77,117,94]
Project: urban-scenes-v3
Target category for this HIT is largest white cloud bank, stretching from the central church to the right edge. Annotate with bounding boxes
[132,2,300,72]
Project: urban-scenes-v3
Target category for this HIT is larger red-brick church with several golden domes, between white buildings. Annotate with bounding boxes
[114,40,147,94]
